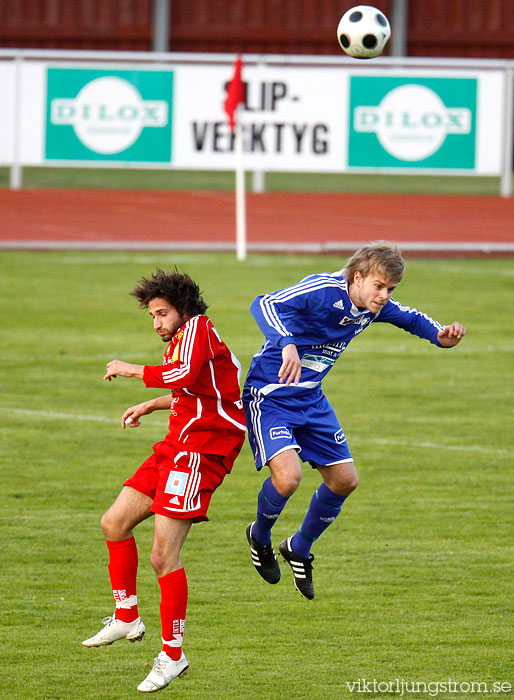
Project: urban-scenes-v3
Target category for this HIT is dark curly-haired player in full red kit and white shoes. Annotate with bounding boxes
[82,270,245,692]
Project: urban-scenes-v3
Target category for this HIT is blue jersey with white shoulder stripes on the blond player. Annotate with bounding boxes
[246,273,443,398]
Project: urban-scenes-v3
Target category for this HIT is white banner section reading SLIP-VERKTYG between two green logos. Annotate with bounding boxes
[174,66,348,172]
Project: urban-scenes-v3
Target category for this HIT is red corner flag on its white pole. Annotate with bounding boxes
[224,56,246,260]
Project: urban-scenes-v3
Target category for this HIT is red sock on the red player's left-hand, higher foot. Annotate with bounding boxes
[106,537,139,622]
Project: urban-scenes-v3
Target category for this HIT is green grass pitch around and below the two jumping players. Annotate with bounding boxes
[0,252,514,700]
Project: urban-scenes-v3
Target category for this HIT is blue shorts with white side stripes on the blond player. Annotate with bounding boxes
[243,387,353,469]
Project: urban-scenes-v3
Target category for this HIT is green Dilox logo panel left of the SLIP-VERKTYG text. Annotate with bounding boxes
[45,68,173,163]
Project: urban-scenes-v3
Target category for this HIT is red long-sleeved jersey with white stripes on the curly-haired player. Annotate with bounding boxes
[143,315,246,456]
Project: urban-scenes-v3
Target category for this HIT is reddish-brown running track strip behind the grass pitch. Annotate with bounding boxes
[0,189,514,255]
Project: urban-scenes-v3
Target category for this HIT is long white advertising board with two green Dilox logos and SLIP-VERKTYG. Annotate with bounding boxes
[0,50,514,197]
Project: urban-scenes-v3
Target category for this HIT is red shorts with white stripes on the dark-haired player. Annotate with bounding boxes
[124,442,235,523]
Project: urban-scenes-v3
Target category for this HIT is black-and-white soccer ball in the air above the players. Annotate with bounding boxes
[337,5,391,58]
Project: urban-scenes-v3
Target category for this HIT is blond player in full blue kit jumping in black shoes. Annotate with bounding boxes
[243,241,466,599]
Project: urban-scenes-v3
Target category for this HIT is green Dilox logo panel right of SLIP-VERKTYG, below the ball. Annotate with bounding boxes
[348,76,477,170]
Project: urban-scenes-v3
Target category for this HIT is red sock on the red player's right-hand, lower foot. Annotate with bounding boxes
[157,568,187,661]
